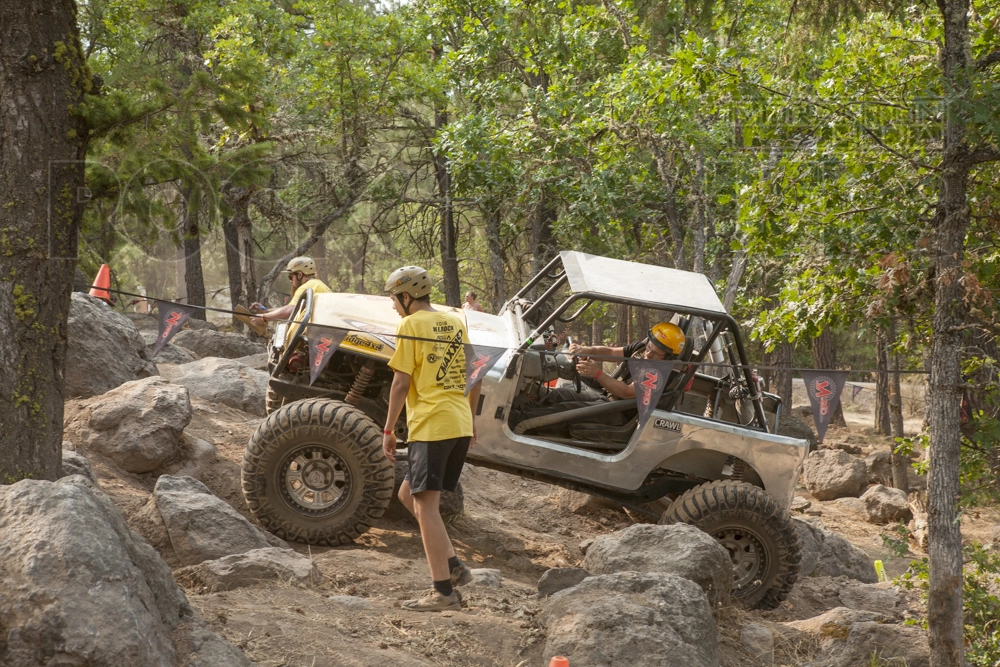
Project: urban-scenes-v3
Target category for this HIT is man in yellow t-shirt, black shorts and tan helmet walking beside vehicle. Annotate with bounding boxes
[382,266,479,611]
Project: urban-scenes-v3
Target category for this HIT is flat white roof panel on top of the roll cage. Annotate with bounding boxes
[559,250,726,314]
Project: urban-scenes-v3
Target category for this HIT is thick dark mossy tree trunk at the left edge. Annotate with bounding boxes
[0,0,91,484]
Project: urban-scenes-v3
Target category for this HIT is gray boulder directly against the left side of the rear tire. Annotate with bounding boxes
[583,523,733,609]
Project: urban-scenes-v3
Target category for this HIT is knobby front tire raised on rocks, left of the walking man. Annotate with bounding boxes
[241,398,393,546]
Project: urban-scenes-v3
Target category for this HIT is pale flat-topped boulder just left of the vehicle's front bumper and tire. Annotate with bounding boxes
[165,357,268,416]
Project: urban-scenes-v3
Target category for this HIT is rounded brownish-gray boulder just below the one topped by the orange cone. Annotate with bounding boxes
[65,377,192,473]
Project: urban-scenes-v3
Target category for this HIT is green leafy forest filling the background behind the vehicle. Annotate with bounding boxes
[0,0,1000,665]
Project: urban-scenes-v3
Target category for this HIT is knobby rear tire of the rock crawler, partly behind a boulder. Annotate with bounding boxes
[660,481,802,609]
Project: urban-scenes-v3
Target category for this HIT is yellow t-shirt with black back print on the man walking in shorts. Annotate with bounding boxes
[389,310,472,442]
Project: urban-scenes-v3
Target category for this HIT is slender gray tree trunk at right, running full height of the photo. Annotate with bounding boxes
[927,0,971,667]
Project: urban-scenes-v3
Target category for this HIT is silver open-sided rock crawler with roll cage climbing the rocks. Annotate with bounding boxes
[242,252,808,607]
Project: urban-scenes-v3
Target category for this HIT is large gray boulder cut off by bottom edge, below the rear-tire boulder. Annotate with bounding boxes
[539,572,719,667]
